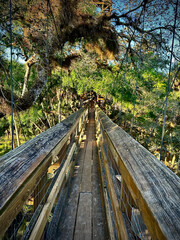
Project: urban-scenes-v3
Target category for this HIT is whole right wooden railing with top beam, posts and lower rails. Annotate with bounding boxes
[96,107,180,240]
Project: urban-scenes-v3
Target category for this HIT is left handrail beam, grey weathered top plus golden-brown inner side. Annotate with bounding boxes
[0,109,87,236]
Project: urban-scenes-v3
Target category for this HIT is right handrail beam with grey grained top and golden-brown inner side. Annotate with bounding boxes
[96,108,180,240]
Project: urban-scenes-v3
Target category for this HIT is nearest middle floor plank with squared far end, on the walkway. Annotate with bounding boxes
[74,193,92,240]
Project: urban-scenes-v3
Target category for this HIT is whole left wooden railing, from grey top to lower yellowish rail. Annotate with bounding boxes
[0,109,88,239]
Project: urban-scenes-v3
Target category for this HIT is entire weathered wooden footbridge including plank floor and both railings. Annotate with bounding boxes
[0,107,180,240]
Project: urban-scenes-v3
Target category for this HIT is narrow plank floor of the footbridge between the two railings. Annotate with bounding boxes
[52,109,108,240]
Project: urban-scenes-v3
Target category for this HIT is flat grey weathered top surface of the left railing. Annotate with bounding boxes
[0,109,84,214]
